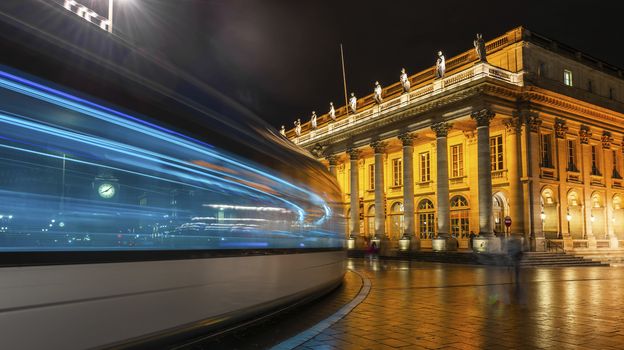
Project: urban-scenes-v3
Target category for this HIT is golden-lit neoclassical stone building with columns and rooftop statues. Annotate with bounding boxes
[286,27,624,250]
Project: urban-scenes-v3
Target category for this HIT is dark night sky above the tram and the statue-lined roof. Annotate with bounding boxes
[97,0,624,127]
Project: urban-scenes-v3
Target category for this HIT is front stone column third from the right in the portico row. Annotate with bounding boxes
[399,133,420,249]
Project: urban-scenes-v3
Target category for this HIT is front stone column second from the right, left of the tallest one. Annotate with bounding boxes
[431,122,452,236]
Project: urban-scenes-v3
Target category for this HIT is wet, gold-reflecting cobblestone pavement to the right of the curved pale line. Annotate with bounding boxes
[297,259,624,350]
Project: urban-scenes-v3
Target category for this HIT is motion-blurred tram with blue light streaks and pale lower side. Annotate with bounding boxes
[0,0,345,349]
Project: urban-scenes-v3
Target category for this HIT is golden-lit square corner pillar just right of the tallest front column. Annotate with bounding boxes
[505,117,524,235]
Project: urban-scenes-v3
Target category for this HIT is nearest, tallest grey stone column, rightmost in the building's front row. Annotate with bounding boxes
[471,109,494,236]
